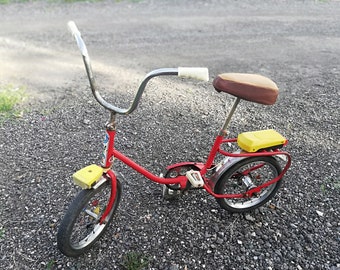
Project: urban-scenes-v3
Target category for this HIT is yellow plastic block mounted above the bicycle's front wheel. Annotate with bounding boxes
[73,164,104,189]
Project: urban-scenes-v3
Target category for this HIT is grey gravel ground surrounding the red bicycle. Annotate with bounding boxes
[0,0,340,270]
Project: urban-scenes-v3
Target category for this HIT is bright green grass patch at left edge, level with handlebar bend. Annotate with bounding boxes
[0,84,26,122]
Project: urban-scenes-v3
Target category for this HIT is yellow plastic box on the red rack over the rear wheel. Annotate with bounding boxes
[237,129,287,152]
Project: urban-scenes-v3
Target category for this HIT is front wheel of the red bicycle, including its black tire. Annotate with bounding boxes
[57,180,122,257]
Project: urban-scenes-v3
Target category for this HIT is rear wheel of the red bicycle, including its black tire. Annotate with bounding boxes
[215,157,282,213]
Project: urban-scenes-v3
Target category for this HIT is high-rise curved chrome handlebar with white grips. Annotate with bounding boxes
[67,21,209,114]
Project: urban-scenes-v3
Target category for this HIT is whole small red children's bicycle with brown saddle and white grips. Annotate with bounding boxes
[57,22,291,257]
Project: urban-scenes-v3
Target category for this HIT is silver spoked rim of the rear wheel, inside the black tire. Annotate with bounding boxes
[223,161,278,209]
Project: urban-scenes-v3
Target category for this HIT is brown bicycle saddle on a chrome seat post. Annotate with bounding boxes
[213,73,279,105]
